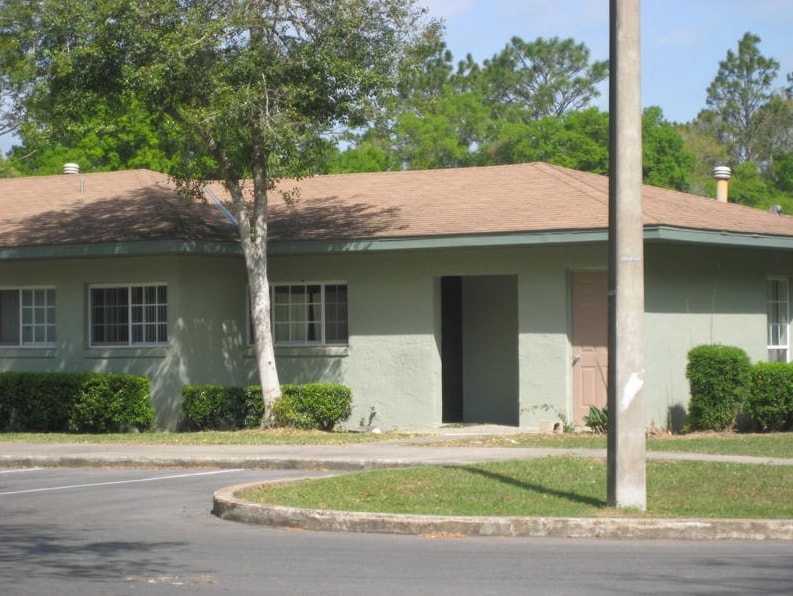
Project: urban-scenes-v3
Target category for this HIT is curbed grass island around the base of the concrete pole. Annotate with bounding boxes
[239,456,793,519]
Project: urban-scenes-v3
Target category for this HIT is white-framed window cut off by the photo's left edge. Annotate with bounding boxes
[0,286,58,348]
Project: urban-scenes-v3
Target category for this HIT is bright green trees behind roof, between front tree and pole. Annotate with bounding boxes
[334,38,607,171]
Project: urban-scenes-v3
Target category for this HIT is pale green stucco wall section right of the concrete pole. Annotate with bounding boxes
[645,245,793,428]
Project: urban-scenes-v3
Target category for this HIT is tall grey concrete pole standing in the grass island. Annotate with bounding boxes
[608,0,647,511]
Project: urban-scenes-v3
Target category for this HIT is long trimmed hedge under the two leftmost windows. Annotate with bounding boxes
[0,372,154,433]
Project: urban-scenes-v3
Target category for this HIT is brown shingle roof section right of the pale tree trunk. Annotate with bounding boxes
[252,163,793,240]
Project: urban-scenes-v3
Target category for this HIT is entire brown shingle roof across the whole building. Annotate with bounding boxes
[0,163,793,247]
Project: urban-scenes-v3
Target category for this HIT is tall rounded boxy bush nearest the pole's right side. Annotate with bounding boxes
[686,345,752,431]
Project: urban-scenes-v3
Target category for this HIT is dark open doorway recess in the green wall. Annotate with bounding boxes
[441,275,520,426]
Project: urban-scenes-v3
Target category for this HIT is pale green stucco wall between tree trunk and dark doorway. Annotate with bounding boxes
[271,255,441,429]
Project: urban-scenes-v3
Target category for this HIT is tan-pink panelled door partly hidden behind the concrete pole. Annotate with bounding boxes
[573,271,608,424]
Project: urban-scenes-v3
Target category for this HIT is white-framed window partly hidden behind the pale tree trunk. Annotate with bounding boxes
[247,281,350,347]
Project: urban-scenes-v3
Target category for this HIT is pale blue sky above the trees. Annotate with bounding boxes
[0,0,793,150]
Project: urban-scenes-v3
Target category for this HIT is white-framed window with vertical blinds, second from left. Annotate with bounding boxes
[88,282,169,348]
